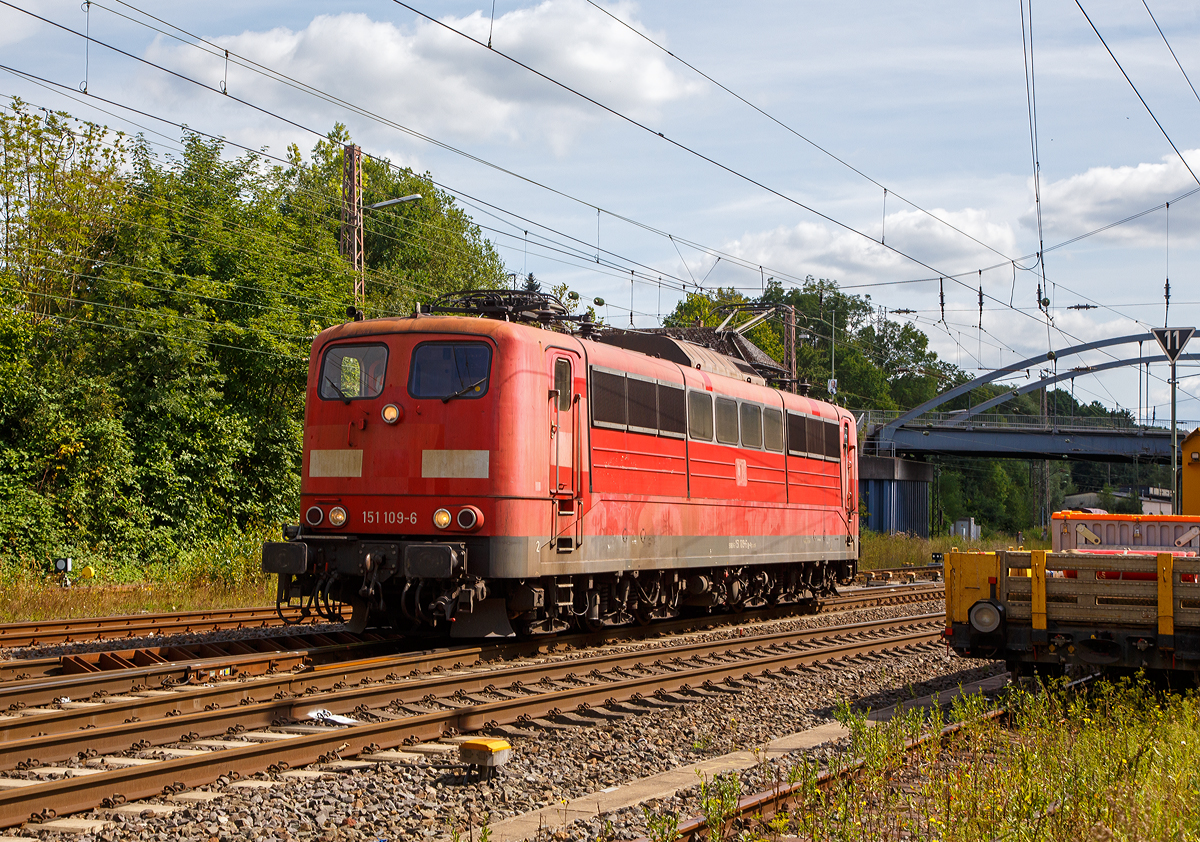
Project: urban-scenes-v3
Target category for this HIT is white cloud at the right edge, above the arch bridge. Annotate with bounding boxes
[1021,149,1200,242]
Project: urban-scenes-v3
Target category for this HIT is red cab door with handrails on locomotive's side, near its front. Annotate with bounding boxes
[547,349,581,553]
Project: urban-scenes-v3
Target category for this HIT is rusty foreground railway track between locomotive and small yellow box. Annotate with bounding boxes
[0,606,942,826]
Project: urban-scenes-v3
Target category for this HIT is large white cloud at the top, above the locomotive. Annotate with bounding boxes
[148,0,700,154]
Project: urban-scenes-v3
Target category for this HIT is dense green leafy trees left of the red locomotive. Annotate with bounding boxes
[0,107,503,573]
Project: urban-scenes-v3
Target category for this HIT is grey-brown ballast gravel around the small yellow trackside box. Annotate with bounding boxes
[37,602,1003,842]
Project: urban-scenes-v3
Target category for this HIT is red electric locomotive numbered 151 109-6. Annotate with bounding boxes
[263,291,858,637]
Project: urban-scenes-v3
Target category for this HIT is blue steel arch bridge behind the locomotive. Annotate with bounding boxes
[858,332,1185,536]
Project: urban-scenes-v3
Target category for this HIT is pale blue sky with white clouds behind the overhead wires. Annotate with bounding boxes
[0,0,1200,419]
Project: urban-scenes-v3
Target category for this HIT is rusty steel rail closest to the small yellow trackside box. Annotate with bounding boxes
[0,620,940,826]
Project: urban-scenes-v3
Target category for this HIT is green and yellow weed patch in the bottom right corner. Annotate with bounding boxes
[739,680,1200,842]
